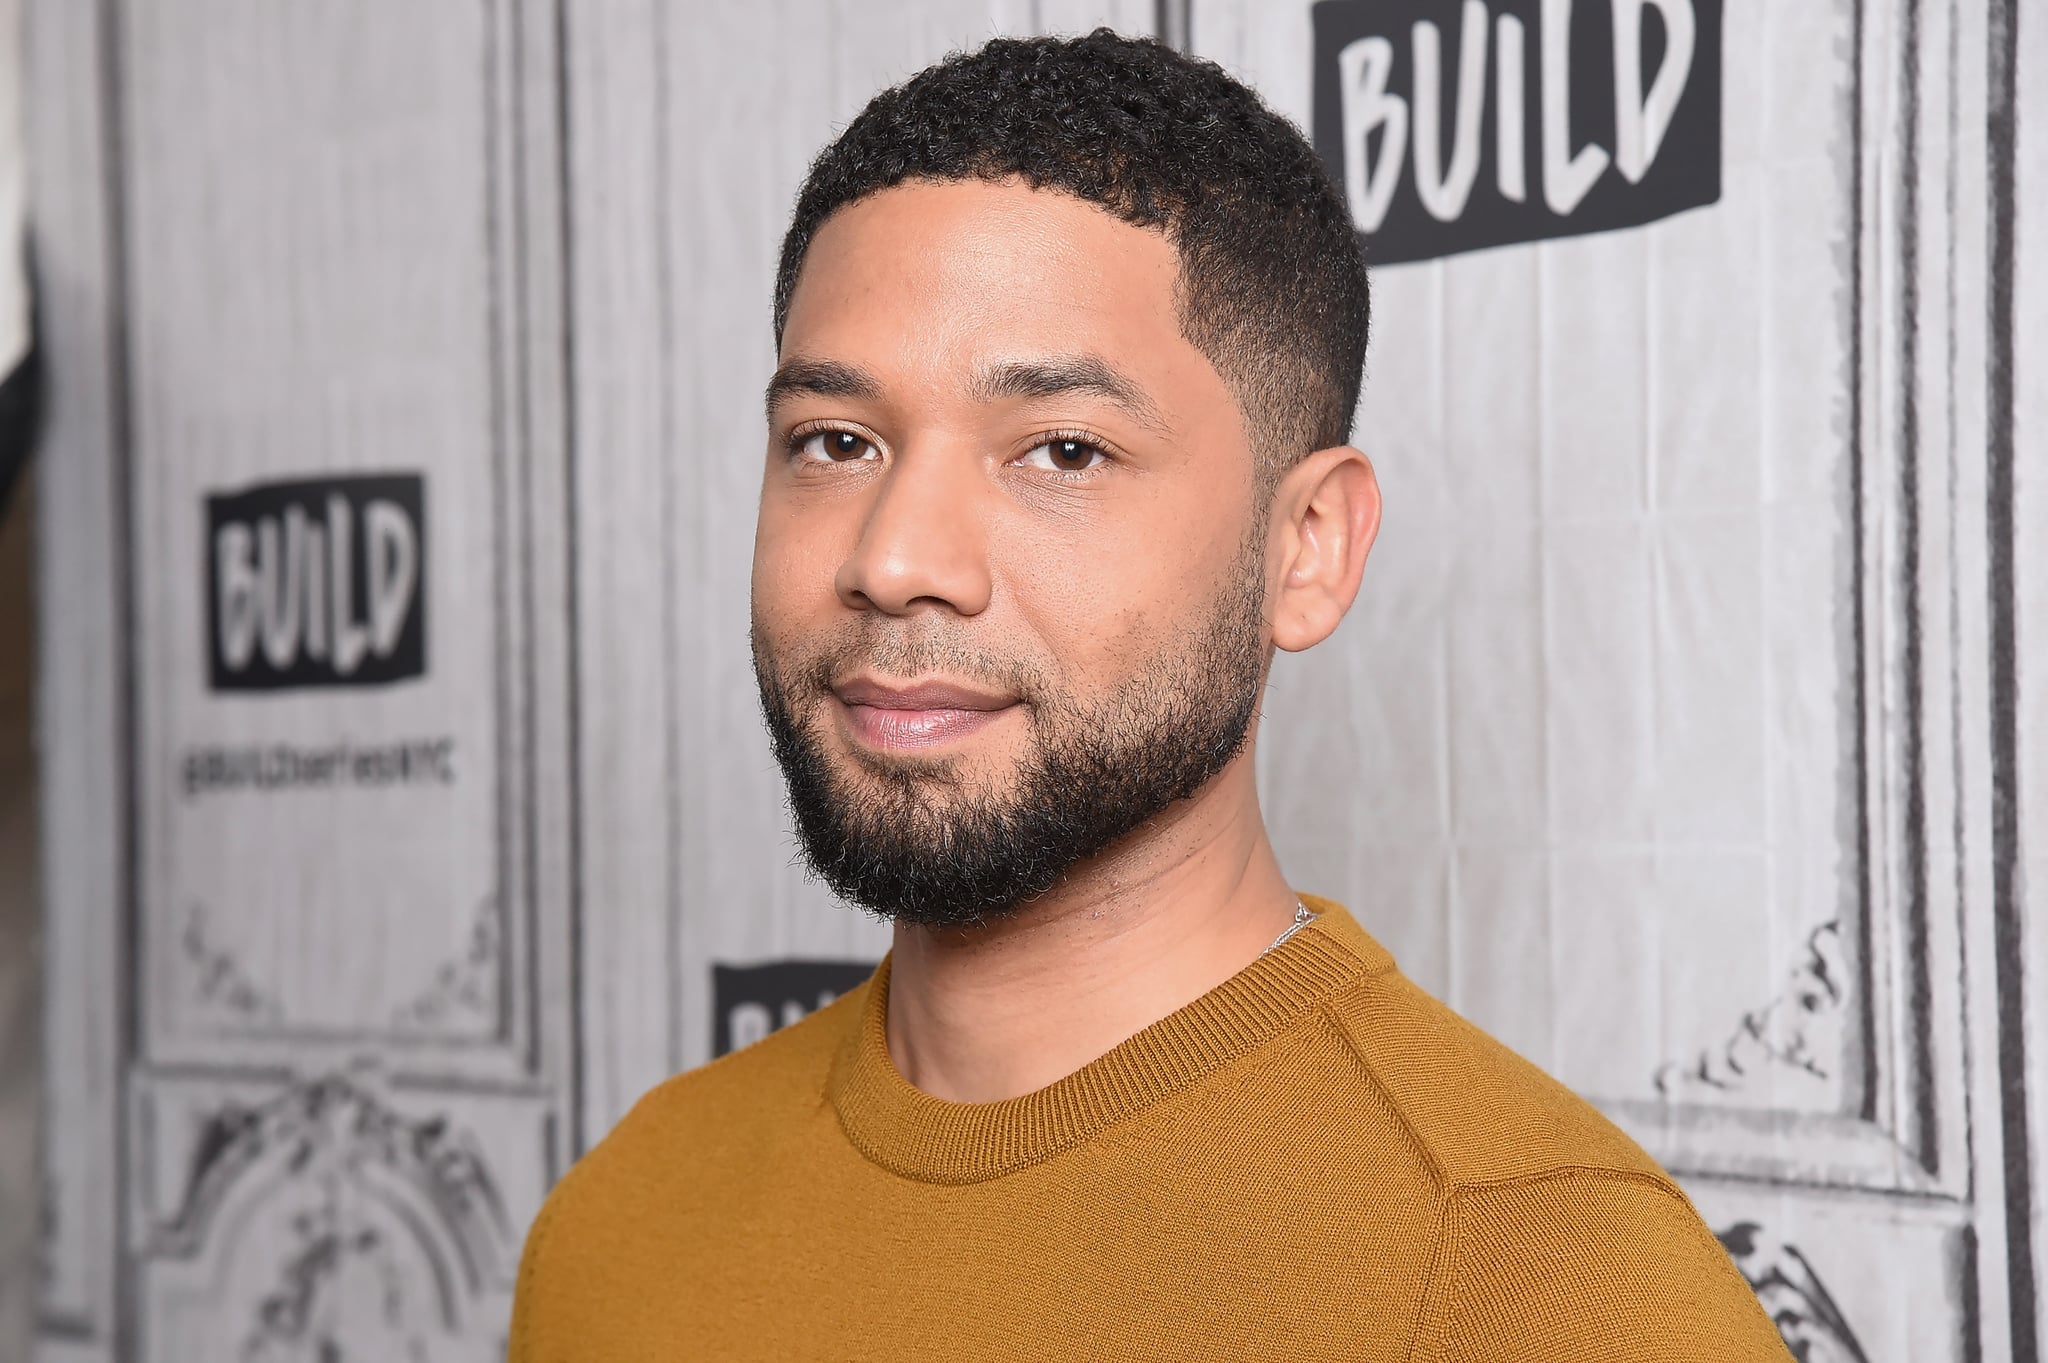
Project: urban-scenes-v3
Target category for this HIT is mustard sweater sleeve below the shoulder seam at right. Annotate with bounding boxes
[1413,1171,1790,1363]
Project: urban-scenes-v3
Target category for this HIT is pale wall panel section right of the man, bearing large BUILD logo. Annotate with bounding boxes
[1192,0,2007,1359]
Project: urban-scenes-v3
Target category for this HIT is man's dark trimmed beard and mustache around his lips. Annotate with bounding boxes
[754,542,1266,927]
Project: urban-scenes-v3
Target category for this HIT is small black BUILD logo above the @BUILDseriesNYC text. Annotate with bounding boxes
[207,473,426,692]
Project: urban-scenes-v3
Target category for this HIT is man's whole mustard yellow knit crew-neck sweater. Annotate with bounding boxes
[510,900,1786,1363]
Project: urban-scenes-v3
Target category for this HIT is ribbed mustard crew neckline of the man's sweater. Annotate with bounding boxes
[825,894,1395,1183]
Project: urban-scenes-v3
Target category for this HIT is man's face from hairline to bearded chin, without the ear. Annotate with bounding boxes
[754,182,1268,925]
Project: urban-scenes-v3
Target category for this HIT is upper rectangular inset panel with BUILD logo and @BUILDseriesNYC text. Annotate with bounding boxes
[123,4,540,1060]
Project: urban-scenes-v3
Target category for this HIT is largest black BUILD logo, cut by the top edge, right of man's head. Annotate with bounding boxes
[1313,0,1720,264]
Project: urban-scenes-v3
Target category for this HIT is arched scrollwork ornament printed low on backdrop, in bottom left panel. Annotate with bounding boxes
[152,1074,516,1291]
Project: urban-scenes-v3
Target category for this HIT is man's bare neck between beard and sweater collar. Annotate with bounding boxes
[889,751,1296,1103]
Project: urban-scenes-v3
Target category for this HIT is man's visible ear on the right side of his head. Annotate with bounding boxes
[1268,444,1380,653]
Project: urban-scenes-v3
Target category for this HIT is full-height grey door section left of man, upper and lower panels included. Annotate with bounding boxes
[33,0,573,1361]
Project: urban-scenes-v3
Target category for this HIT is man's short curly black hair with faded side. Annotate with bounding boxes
[774,29,1370,485]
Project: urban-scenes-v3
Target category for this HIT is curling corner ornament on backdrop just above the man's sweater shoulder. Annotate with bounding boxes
[1653,921,1849,1101]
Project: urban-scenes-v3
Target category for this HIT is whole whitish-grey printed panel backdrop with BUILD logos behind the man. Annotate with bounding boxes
[27,0,2048,1363]
